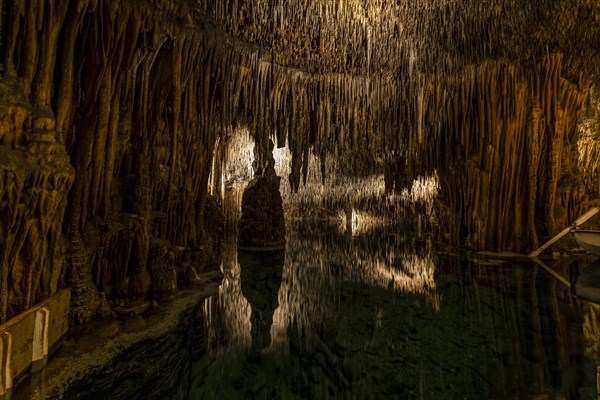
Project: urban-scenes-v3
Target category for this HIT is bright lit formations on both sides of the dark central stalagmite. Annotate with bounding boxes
[220,128,439,235]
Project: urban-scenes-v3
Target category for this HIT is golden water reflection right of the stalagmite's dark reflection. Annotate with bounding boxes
[270,227,441,352]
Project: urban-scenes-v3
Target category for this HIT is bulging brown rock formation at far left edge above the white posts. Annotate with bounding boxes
[0,76,75,323]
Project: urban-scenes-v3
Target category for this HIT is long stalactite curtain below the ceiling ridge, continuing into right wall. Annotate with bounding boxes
[200,17,588,250]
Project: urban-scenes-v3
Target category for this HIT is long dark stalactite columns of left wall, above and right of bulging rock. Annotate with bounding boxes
[0,0,224,242]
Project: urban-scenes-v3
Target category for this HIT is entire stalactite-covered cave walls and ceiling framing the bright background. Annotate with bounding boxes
[0,0,600,322]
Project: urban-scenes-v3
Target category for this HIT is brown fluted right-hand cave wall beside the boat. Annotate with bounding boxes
[414,54,589,251]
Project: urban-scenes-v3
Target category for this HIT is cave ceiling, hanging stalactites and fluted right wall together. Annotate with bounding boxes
[193,0,600,251]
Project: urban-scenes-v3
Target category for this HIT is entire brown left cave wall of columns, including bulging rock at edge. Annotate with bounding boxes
[0,0,223,322]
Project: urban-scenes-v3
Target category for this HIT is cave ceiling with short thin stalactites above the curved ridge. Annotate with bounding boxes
[198,0,600,80]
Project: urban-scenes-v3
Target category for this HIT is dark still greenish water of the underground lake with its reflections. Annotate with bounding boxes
[184,226,600,399]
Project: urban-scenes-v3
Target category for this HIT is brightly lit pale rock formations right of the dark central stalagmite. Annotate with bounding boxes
[273,144,440,227]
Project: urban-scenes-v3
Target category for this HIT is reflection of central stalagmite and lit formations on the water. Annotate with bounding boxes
[207,227,440,352]
